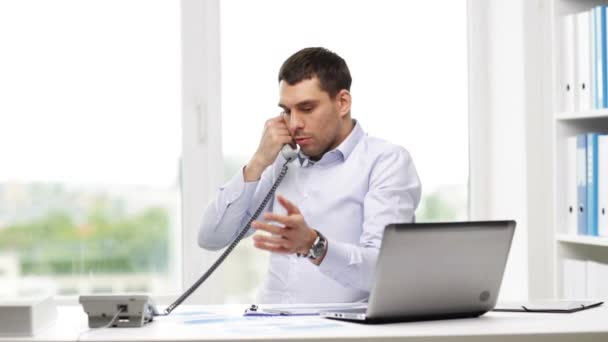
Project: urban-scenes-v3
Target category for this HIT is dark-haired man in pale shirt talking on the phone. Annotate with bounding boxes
[198,48,421,303]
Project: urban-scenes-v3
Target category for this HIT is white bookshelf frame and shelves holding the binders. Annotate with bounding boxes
[548,0,608,299]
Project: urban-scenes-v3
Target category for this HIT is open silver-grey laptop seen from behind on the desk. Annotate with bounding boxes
[320,221,515,323]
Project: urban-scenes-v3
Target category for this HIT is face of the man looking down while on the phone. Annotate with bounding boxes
[279,77,343,160]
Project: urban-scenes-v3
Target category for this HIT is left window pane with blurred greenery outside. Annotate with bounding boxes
[0,0,181,295]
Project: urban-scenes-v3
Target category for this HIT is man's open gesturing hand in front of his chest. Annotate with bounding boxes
[251,195,322,264]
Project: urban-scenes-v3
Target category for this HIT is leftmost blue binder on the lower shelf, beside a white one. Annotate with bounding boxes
[576,134,587,235]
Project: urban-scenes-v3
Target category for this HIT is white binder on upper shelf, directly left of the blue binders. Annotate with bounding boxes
[573,11,592,110]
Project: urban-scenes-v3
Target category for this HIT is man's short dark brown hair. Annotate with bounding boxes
[279,47,352,98]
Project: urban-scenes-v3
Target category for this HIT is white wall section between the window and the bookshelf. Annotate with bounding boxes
[469,0,550,300]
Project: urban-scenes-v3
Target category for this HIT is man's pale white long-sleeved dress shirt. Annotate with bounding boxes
[198,122,421,303]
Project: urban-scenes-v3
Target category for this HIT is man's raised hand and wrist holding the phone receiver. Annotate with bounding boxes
[243,115,293,182]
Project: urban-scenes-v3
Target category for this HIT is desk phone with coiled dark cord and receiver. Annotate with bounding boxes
[79,145,299,328]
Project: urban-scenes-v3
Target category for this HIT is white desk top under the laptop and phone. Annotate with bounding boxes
[0,304,608,342]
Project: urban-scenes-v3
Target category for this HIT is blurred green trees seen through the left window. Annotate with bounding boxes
[0,203,169,275]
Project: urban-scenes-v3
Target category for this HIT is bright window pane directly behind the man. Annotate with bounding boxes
[220,0,468,302]
